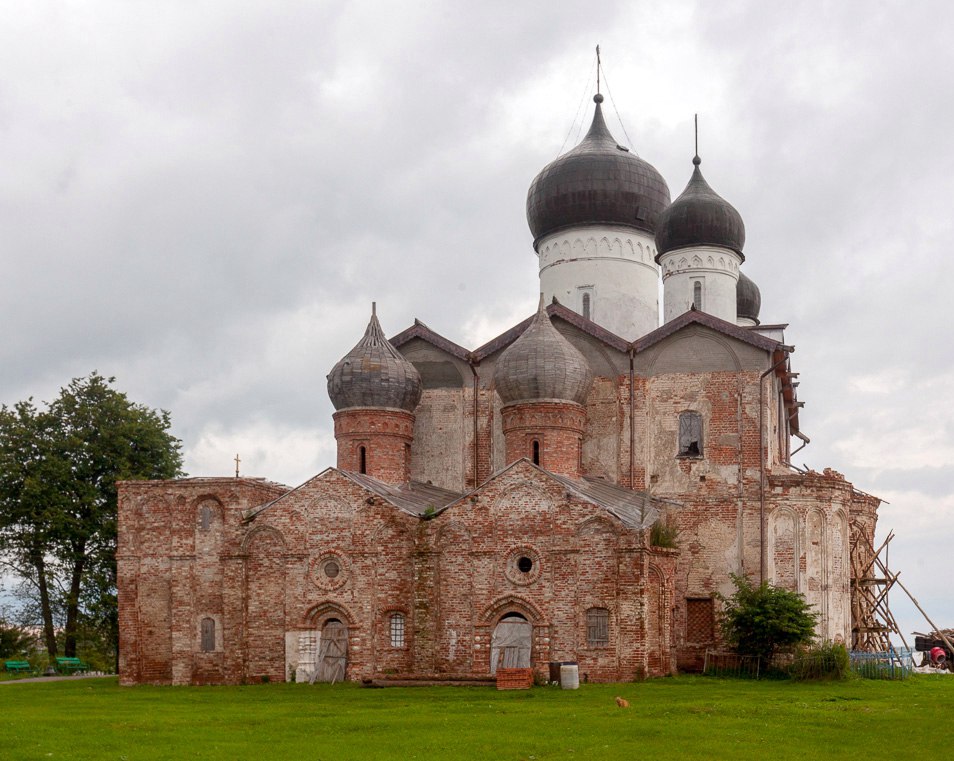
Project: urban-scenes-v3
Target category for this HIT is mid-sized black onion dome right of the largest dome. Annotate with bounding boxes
[656,156,745,262]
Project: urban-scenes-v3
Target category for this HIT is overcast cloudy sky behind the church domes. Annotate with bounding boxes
[0,0,954,648]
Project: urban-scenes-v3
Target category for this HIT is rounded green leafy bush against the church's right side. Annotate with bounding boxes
[720,574,818,661]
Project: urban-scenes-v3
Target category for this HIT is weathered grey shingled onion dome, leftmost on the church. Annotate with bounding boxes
[328,306,421,412]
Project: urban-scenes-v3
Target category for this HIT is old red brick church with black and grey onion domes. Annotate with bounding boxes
[117,94,879,684]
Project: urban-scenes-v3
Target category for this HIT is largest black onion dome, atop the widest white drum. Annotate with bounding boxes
[527,94,669,242]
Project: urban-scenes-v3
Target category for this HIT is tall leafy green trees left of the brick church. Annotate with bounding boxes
[0,372,182,656]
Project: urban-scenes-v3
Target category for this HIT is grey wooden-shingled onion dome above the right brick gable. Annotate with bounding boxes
[494,298,593,404]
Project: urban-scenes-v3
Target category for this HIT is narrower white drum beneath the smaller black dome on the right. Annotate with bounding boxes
[659,246,742,323]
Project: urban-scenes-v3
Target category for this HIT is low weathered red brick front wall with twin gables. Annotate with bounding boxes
[120,463,674,684]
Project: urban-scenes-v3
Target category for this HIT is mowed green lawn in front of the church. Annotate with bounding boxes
[0,676,954,761]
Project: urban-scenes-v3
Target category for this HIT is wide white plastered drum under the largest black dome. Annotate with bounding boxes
[536,226,659,340]
